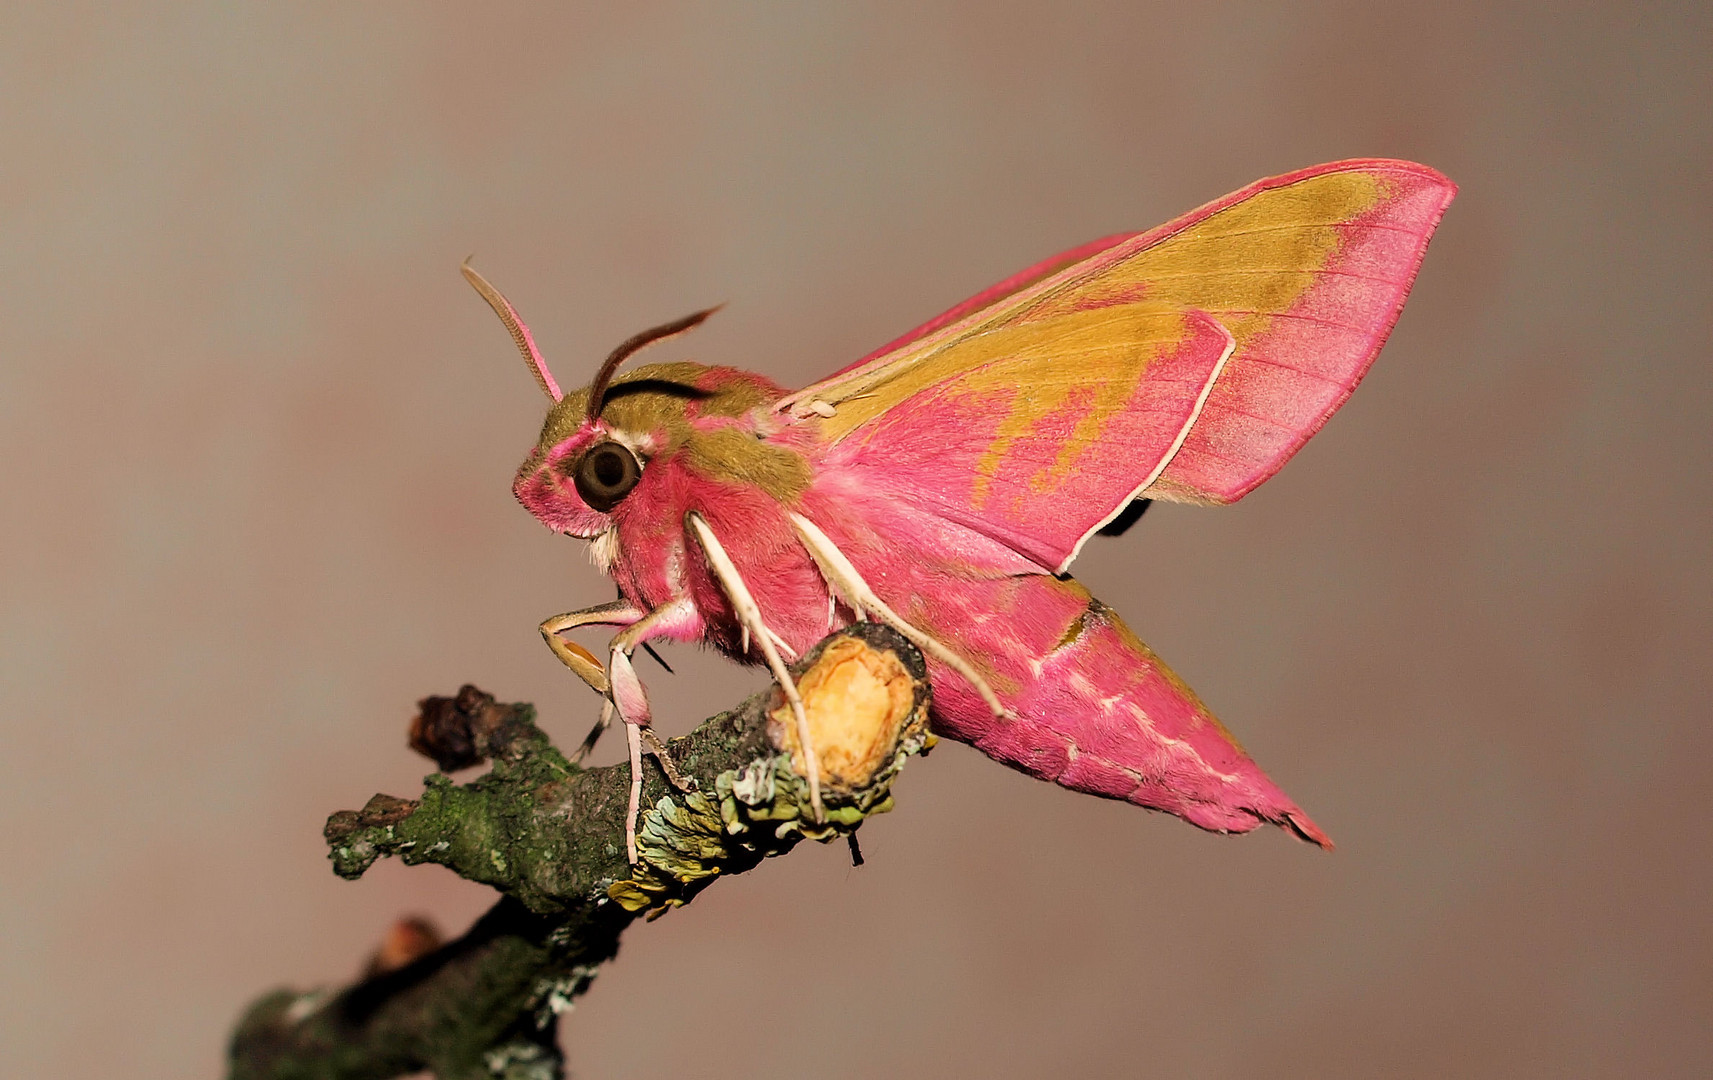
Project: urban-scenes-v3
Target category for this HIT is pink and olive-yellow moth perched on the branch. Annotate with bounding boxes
[464,159,1456,862]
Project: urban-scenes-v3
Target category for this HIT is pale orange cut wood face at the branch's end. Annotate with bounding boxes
[771,638,916,792]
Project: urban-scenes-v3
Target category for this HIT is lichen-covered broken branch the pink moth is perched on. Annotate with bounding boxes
[230,624,932,1080]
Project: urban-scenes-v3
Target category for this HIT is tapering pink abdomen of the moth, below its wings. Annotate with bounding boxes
[918,574,1331,847]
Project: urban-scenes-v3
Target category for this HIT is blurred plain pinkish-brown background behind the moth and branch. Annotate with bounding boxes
[0,0,1713,1080]
